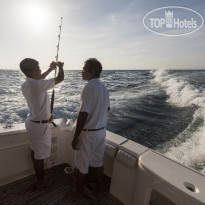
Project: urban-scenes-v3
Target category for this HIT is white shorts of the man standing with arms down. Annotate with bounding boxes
[75,129,106,174]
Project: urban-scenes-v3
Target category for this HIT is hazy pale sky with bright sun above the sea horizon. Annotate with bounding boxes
[0,0,205,70]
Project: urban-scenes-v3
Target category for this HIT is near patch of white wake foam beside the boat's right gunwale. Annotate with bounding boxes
[163,109,205,170]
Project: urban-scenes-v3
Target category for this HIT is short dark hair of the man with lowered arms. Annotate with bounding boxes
[85,58,102,78]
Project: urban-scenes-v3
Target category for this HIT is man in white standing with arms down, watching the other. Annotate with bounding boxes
[72,58,110,201]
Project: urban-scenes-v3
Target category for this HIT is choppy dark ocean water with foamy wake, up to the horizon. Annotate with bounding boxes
[0,70,205,173]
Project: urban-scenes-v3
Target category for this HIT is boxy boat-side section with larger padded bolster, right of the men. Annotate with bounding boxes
[110,140,149,205]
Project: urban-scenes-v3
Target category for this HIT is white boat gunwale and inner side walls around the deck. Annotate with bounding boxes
[0,121,205,205]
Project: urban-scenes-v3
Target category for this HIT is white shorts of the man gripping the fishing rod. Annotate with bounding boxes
[26,120,51,159]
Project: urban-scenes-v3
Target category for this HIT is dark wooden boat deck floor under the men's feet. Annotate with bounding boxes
[0,164,122,205]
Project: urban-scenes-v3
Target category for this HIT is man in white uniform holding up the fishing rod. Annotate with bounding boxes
[20,58,64,188]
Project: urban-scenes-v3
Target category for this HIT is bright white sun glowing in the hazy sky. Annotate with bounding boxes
[23,2,48,32]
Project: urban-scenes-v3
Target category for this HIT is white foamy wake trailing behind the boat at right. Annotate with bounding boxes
[151,70,205,172]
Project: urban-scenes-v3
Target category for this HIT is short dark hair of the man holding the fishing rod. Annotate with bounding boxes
[19,58,39,76]
